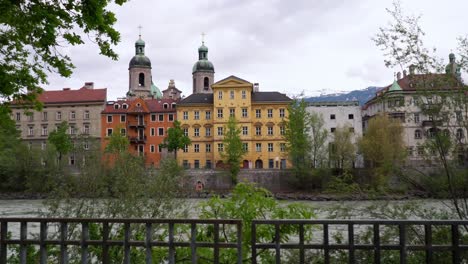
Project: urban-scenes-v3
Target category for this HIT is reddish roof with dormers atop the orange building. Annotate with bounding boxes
[102,99,178,114]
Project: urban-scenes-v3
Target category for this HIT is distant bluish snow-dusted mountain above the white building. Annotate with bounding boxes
[304,86,381,105]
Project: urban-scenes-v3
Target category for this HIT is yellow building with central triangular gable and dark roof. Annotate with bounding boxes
[177,76,291,169]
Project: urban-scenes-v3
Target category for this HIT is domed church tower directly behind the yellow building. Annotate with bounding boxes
[192,38,214,94]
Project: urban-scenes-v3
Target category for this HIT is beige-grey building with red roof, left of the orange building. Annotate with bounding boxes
[11,82,107,165]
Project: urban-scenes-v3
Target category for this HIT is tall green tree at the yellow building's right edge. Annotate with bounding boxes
[284,99,312,181]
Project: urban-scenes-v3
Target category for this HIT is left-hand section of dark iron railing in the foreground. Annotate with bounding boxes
[0,218,242,264]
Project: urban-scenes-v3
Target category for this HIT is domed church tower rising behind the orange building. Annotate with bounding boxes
[127,35,152,98]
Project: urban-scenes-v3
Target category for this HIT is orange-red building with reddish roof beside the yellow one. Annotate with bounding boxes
[101,98,177,167]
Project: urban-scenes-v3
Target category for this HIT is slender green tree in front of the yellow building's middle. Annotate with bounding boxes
[221,117,245,184]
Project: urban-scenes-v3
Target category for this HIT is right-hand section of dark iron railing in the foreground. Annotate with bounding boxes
[251,220,468,264]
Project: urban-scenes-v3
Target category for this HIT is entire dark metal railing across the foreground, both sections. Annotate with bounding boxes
[0,218,468,264]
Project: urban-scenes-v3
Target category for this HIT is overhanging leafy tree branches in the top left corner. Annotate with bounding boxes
[0,0,126,109]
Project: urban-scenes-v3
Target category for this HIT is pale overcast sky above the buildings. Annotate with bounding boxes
[45,0,468,100]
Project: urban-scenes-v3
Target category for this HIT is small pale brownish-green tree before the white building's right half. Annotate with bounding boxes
[330,126,356,169]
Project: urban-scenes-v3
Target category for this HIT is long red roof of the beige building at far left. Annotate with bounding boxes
[38,87,107,104]
